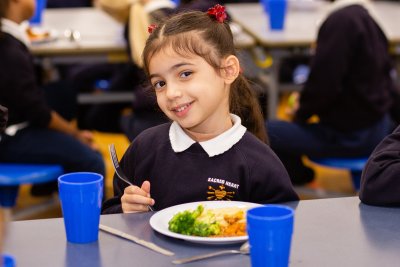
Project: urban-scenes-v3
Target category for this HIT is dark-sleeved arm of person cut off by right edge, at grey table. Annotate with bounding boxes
[359,126,400,206]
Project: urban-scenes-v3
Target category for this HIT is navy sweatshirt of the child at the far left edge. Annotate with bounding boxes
[0,33,51,127]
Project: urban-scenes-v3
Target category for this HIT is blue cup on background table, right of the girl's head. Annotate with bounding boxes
[262,0,287,31]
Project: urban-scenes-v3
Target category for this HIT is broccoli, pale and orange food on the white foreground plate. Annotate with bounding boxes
[168,205,246,237]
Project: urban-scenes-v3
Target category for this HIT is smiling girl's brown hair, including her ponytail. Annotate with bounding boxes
[142,11,268,143]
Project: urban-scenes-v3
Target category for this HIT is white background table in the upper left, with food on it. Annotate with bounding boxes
[31,8,127,62]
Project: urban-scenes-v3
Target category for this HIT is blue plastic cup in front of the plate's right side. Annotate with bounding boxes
[247,205,294,267]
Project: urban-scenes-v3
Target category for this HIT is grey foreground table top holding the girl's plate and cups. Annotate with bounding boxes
[4,197,400,267]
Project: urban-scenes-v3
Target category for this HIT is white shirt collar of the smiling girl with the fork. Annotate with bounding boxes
[169,114,247,157]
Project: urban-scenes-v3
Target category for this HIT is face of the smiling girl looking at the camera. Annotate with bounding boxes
[149,48,231,134]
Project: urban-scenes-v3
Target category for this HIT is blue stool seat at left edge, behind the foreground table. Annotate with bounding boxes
[0,163,63,208]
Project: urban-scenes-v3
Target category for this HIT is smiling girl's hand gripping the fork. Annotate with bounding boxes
[121,181,154,213]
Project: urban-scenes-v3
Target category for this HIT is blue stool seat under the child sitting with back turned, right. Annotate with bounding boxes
[310,157,368,191]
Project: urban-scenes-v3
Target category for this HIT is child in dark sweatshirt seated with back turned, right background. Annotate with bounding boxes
[268,0,395,185]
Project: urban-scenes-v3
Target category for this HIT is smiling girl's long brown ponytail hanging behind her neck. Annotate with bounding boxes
[229,74,269,144]
